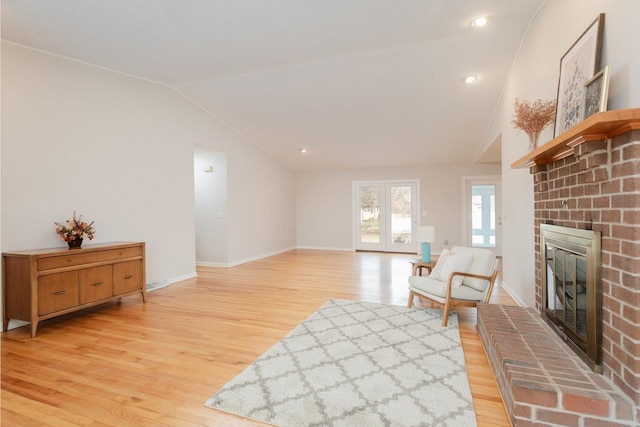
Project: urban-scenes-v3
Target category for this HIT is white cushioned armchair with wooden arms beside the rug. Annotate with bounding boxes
[407,246,498,326]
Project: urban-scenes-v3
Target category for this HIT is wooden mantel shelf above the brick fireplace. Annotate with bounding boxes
[511,108,640,169]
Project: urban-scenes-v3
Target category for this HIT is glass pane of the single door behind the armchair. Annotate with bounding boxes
[471,185,496,247]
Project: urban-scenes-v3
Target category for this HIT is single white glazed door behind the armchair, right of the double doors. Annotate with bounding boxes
[465,177,502,256]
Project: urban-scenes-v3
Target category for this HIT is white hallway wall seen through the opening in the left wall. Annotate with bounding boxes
[193,152,227,266]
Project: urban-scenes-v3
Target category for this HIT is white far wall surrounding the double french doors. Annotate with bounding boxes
[296,163,500,252]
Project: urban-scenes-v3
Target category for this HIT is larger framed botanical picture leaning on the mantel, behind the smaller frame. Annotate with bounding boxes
[554,13,604,136]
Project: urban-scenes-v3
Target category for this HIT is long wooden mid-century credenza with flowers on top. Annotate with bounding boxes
[2,242,146,337]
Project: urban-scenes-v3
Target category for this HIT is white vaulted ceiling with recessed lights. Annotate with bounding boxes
[2,0,543,170]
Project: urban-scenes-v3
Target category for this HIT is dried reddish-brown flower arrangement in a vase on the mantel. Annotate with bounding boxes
[511,98,556,151]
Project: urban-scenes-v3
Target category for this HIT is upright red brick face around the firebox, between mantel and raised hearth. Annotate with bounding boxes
[531,130,640,402]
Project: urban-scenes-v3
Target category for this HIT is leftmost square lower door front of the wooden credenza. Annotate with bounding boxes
[38,271,78,316]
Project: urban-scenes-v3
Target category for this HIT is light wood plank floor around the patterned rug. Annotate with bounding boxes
[1,250,513,426]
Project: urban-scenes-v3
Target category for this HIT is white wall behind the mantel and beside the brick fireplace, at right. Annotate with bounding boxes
[485,0,640,306]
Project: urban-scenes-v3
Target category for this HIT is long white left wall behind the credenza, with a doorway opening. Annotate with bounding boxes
[1,42,295,290]
